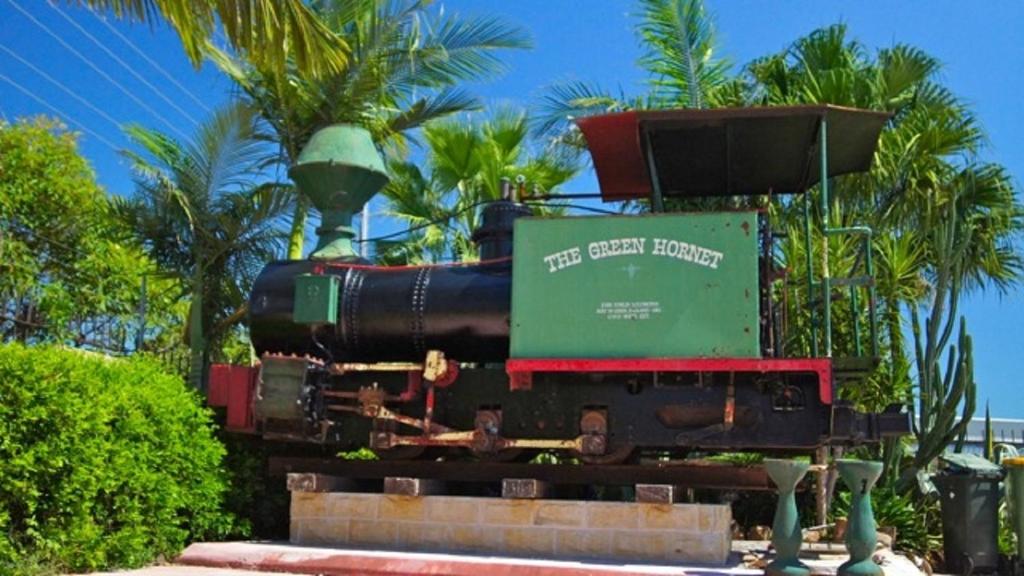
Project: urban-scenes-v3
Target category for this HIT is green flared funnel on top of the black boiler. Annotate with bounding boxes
[288,124,388,260]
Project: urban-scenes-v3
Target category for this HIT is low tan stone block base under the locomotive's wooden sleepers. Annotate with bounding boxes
[290,483,732,564]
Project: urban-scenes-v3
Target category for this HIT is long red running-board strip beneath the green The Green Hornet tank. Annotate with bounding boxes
[505,358,833,404]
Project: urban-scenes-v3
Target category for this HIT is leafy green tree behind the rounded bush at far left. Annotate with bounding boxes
[0,117,176,352]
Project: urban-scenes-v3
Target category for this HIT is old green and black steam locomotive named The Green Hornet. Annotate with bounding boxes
[210,106,908,463]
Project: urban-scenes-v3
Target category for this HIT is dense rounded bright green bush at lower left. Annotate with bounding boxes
[0,344,232,574]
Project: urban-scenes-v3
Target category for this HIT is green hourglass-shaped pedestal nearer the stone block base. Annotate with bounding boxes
[765,459,811,576]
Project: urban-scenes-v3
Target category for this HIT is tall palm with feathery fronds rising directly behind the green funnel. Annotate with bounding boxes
[206,0,529,258]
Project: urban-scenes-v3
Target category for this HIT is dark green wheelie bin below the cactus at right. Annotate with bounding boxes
[932,454,1002,574]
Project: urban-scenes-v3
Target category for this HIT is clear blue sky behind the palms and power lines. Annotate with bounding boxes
[0,0,1024,417]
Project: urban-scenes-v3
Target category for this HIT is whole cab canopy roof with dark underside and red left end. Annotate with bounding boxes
[577,105,890,201]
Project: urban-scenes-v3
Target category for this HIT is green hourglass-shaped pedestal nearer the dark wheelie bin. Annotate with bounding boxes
[836,460,884,576]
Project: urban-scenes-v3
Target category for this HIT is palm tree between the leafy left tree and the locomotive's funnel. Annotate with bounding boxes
[117,104,292,387]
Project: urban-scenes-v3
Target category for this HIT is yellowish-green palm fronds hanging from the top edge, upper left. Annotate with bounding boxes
[76,0,349,76]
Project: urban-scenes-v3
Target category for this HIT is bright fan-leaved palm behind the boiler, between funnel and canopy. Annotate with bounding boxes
[384,109,579,261]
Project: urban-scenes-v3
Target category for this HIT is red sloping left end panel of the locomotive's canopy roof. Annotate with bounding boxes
[577,112,651,202]
